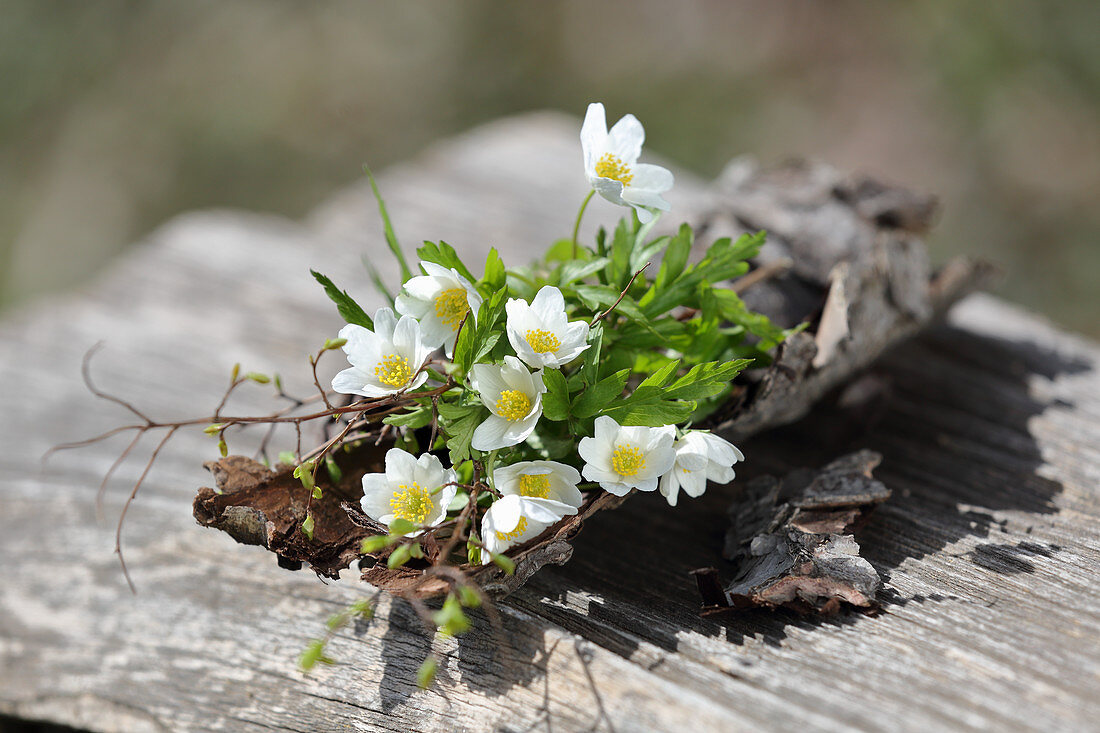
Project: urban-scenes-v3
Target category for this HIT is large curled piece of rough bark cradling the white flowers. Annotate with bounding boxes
[195,161,991,598]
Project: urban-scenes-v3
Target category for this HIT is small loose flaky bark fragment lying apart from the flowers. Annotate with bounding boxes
[695,450,890,615]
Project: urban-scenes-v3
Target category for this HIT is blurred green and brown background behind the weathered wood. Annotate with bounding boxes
[0,0,1100,336]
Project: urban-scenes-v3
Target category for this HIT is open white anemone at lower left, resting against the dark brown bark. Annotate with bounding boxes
[361,448,458,537]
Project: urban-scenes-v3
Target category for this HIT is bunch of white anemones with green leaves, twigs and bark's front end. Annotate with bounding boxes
[77,103,798,668]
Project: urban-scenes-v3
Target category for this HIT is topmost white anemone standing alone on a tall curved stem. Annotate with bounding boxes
[581,102,673,223]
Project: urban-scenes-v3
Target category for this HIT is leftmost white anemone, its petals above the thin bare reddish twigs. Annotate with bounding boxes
[332,308,431,397]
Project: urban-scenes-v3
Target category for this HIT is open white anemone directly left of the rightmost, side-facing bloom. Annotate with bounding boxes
[576,415,677,496]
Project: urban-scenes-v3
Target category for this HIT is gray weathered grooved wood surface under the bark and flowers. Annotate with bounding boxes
[0,116,1100,731]
